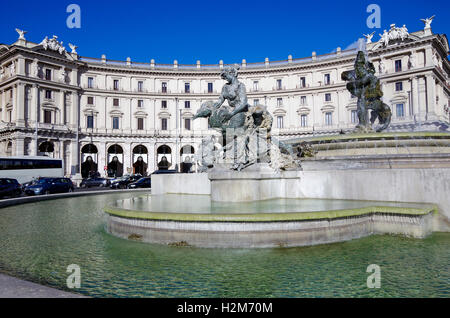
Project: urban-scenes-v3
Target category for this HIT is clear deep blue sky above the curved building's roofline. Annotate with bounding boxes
[0,0,450,64]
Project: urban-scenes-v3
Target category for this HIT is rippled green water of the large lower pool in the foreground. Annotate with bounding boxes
[0,194,450,297]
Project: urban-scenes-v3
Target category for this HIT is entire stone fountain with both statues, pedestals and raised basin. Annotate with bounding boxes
[105,60,450,248]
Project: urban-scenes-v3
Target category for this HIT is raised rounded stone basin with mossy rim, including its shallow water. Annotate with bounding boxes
[105,194,437,248]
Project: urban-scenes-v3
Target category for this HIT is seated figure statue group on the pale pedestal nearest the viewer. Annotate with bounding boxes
[194,66,298,171]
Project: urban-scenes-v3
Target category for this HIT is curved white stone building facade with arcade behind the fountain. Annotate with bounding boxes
[0,25,450,176]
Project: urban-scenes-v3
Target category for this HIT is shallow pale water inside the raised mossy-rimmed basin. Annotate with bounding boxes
[116,194,430,214]
